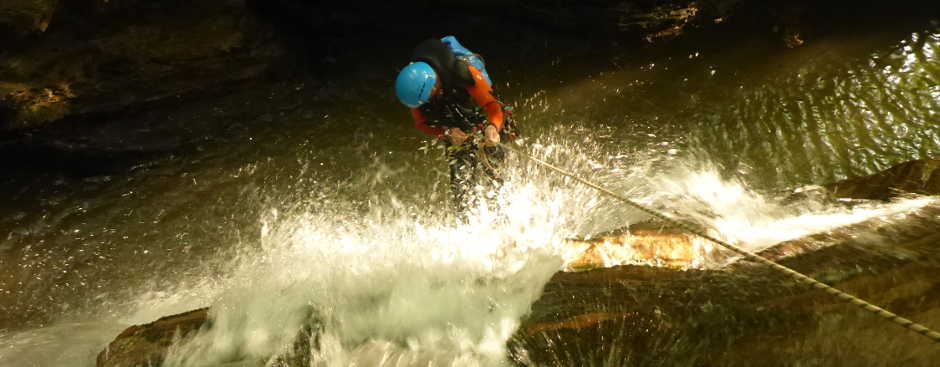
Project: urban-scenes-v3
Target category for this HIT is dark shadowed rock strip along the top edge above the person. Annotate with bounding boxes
[252,0,744,41]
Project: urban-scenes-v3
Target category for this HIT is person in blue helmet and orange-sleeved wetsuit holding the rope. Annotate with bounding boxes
[395,36,508,219]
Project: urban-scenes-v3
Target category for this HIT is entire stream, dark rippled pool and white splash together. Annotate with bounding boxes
[0,18,940,366]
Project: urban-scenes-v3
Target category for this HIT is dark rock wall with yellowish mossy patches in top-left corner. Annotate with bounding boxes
[0,0,282,131]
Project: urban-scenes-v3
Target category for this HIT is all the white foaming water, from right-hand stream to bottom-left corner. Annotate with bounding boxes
[0,132,936,366]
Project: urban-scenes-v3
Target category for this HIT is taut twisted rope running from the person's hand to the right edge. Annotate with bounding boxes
[503,144,940,343]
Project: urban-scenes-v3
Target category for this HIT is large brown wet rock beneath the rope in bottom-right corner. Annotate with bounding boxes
[509,205,940,366]
